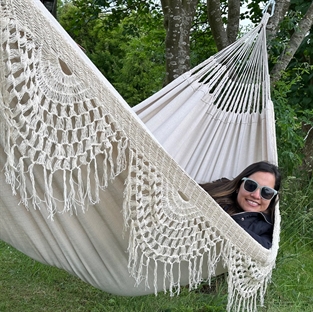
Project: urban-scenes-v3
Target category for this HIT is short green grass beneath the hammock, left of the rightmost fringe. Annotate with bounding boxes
[0,241,227,312]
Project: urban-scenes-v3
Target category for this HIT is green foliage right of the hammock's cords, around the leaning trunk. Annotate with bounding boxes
[269,0,313,175]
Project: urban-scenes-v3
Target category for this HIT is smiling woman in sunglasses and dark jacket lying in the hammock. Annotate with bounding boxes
[201,161,281,249]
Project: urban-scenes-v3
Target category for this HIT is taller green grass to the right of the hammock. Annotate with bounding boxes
[263,177,313,312]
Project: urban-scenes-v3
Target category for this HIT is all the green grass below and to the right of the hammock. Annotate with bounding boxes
[0,174,313,312]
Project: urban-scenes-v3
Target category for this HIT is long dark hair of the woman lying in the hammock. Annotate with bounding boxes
[200,161,281,219]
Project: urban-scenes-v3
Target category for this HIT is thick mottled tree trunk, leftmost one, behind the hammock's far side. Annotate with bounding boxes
[161,0,198,84]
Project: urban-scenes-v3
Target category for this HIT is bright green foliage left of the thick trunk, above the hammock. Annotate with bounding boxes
[90,13,165,106]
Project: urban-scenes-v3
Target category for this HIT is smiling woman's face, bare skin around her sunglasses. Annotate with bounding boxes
[237,171,275,212]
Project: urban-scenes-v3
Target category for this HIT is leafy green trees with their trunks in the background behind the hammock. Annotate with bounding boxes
[60,0,313,173]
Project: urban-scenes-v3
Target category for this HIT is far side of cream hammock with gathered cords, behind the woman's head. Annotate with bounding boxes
[134,14,277,183]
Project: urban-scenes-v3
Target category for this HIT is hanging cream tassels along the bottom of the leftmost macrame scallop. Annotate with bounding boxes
[1,109,128,219]
